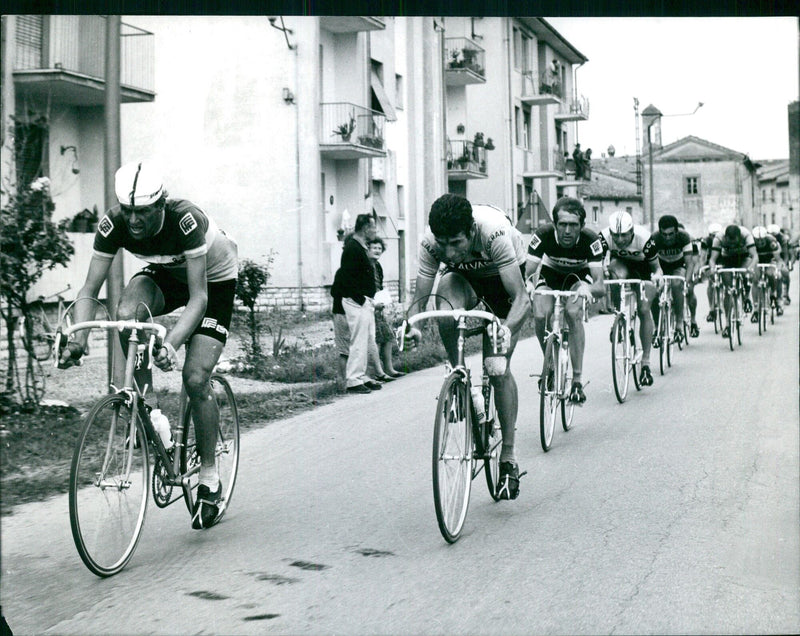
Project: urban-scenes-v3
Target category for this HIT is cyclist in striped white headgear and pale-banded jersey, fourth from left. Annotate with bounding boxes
[601,210,661,386]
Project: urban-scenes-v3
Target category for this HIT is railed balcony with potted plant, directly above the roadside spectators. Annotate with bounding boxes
[319,102,386,160]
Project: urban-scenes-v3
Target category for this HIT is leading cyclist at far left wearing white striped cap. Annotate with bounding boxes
[56,161,238,529]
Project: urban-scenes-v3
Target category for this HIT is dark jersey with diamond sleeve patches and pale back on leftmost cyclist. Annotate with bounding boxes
[94,199,238,282]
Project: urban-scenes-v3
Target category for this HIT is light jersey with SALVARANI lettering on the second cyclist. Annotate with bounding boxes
[418,205,525,279]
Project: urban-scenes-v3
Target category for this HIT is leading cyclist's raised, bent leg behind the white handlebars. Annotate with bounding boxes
[114,269,169,407]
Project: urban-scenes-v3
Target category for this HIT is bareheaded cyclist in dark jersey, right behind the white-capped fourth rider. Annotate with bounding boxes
[651,214,700,348]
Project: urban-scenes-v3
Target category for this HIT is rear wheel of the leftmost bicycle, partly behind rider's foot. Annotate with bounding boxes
[180,375,239,522]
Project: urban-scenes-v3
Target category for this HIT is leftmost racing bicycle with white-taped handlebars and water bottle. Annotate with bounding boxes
[56,320,239,577]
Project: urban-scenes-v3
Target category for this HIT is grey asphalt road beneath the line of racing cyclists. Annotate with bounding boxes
[0,280,800,634]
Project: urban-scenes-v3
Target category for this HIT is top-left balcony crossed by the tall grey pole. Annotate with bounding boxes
[14,15,155,106]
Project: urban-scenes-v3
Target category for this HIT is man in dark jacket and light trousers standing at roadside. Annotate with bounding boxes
[337,214,381,393]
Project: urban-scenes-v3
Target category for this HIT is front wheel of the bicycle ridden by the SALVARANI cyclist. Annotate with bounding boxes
[433,372,473,543]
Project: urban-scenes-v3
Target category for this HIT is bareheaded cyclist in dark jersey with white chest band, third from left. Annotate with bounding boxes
[525,197,606,404]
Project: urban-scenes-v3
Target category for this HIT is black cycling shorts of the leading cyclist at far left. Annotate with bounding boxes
[134,266,236,344]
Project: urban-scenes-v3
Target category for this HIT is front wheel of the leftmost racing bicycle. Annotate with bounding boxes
[69,394,150,577]
